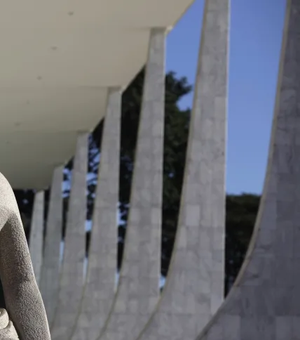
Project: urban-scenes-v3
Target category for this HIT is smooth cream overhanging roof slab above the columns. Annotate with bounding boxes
[0,0,193,189]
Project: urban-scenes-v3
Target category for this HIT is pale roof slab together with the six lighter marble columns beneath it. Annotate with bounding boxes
[0,0,238,340]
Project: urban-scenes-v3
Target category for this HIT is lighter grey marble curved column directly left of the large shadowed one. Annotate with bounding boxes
[138,0,229,340]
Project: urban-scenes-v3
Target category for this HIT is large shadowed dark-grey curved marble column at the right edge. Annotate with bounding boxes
[198,0,300,340]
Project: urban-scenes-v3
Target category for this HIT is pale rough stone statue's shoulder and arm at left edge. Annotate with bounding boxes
[0,174,51,340]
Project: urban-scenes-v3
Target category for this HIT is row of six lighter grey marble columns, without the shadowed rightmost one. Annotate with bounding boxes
[30,0,229,340]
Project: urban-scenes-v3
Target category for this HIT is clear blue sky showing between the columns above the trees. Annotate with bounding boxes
[167,0,286,193]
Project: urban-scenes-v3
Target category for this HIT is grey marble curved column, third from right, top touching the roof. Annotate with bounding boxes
[101,29,165,340]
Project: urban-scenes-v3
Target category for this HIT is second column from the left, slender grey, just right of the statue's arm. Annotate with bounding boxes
[40,166,63,325]
